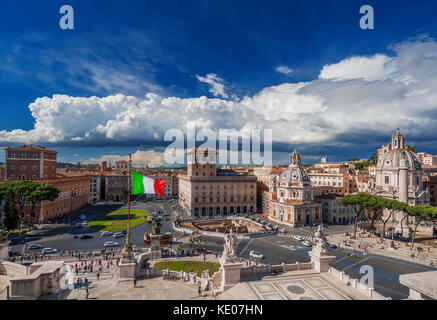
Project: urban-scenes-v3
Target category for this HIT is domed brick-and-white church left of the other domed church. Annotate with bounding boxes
[268,150,322,227]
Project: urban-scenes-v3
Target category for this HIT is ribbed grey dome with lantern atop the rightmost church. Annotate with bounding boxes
[377,129,422,170]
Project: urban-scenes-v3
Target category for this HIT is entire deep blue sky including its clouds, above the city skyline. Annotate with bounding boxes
[0,0,437,162]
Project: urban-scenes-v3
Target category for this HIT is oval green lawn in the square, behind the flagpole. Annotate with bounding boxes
[89,209,149,231]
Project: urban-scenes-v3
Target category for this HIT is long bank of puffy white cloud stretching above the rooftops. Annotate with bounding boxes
[0,39,437,154]
